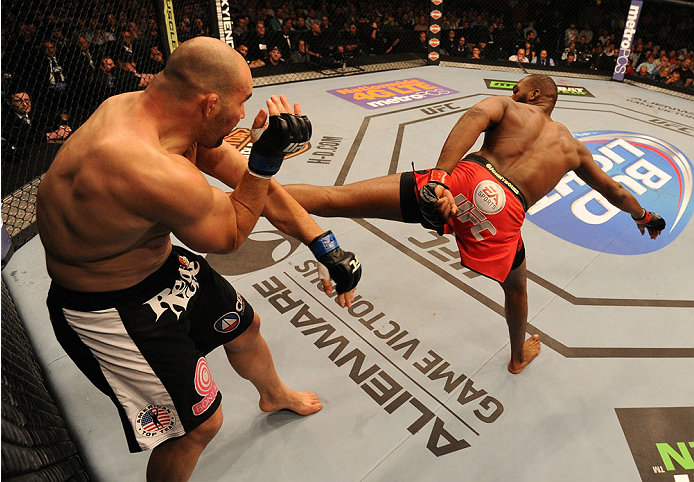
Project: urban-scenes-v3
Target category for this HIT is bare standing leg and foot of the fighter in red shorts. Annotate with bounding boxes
[501,260,541,374]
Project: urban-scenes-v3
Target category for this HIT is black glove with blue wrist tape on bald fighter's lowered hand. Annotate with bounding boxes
[308,231,361,294]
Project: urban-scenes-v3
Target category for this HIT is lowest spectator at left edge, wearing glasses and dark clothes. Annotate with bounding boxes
[1,90,72,152]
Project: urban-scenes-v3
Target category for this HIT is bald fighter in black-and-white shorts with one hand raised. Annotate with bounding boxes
[37,37,361,481]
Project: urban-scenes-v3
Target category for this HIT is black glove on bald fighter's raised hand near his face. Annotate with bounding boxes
[248,113,311,179]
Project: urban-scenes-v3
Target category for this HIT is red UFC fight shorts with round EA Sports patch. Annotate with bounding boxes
[413,154,526,283]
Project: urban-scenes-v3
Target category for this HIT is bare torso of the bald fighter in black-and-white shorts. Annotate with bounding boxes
[37,92,201,291]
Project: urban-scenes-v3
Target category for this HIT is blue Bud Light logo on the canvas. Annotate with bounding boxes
[527,131,694,254]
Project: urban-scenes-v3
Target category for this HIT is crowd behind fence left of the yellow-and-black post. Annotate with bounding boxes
[0,1,173,160]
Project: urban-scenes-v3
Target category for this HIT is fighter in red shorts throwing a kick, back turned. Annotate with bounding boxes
[285,75,665,373]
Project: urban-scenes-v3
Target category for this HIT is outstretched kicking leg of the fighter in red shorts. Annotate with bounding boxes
[283,174,402,221]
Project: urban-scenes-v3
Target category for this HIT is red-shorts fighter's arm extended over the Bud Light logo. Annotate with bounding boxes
[574,140,665,239]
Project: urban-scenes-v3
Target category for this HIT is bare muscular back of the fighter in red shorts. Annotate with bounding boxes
[478,97,585,206]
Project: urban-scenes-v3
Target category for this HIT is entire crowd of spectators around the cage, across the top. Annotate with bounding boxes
[1,0,694,161]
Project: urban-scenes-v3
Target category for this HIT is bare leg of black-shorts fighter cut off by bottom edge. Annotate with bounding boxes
[147,405,223,482]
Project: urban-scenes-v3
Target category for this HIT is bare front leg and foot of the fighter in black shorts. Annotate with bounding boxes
[224,313,323,415]
